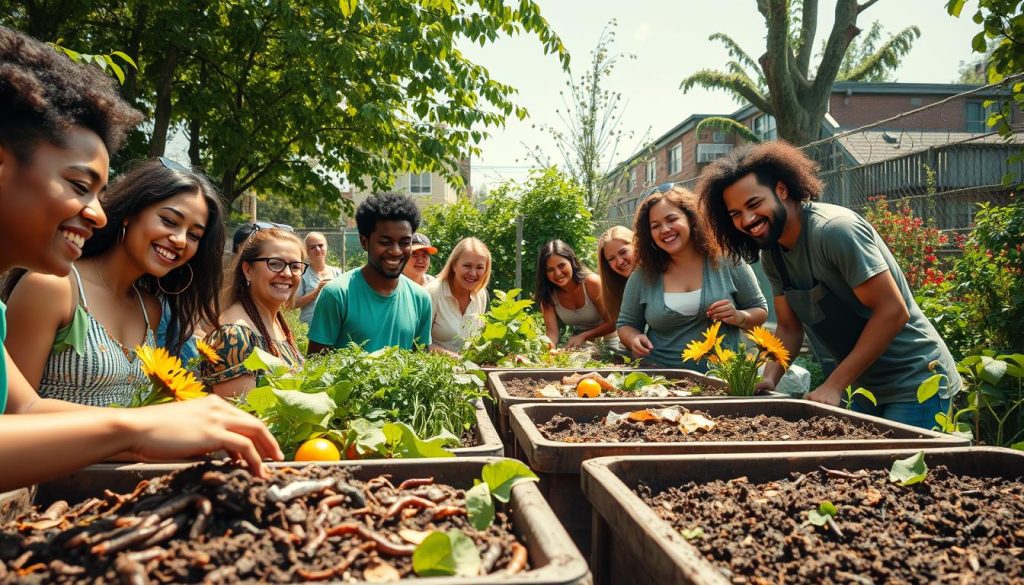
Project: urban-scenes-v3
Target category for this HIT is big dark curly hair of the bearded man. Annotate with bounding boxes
[696,140,824,262]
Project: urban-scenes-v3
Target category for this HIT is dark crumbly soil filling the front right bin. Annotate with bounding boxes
[637,466,1024,585]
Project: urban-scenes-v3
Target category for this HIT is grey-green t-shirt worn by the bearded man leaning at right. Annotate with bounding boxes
[761,203,962,404]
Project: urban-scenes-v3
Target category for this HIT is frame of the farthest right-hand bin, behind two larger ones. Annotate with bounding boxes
[487,368,730,459]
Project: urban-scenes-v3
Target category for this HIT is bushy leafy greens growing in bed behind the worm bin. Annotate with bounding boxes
[240,344,486,457]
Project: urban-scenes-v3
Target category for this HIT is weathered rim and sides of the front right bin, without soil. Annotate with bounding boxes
[582,448,1024,585]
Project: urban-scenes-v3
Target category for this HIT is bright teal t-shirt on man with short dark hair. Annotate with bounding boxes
[309,268,433,351]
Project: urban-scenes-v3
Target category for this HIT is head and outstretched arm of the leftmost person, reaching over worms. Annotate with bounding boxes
[0,27,283,491]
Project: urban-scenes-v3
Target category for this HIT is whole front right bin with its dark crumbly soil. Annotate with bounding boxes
[583,448,1024,585]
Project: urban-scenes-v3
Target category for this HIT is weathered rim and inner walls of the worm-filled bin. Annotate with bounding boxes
[25,457,592,585]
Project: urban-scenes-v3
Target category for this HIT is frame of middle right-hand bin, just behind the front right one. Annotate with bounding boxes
[510,398,970,555]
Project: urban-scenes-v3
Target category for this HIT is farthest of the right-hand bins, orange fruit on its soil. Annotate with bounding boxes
[487,368,726,458]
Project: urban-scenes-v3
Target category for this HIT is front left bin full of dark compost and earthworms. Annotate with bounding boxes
[6,458,590,584]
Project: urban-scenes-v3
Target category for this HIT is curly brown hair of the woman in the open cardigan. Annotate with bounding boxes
[633,184,722,280]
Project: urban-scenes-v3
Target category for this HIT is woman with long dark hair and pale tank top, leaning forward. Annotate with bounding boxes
[536,240,615,349]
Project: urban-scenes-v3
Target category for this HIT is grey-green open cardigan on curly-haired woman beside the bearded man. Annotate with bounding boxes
[615,258,768,372]
